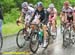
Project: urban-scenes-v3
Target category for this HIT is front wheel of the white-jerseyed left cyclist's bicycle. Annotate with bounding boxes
[16,29,26,48]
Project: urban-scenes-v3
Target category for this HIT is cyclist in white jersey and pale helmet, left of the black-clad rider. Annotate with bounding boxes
[17,2,34,28]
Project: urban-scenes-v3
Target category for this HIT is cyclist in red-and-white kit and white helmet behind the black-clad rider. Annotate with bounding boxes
[47,3,57,35]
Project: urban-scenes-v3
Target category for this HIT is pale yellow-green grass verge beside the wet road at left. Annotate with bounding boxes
[2,23,22,36]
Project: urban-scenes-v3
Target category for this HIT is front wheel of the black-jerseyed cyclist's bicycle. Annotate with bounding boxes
[30,32,39,53]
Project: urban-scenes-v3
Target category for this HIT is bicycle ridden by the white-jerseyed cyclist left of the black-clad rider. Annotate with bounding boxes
[16,21,30,48]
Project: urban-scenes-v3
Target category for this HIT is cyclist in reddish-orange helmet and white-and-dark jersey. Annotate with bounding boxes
[61,1,73,27]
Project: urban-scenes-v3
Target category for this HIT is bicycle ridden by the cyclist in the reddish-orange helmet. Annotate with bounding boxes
[63,22,75,47]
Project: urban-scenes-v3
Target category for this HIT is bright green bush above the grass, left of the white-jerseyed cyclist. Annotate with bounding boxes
[4,8,20,23]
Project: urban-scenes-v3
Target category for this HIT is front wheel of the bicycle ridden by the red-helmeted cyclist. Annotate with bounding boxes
[63,29,70,47]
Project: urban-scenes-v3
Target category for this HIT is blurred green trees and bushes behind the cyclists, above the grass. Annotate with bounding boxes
[0,0,75,33]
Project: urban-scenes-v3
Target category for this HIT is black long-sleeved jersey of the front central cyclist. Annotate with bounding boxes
[31,9,48,24]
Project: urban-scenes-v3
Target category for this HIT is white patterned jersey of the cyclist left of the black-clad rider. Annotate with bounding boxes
[22,6,34,23]
